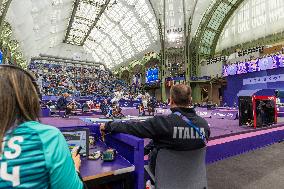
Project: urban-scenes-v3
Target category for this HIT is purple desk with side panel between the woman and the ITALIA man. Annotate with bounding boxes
[57,123,144,189]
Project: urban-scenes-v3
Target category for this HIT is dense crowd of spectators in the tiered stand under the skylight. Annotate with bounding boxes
[29,62,134,98]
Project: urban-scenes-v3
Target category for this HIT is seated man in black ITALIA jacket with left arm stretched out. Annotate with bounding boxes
[100,84,210,173]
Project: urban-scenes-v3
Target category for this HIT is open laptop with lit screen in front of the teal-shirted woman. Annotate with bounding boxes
[61,128,90,157]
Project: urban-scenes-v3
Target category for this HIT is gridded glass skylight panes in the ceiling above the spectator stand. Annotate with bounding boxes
[65,0,158,68]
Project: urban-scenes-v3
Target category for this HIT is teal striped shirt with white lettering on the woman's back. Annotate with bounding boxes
[0,121,83,189]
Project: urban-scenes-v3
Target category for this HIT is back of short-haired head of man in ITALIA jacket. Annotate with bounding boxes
[171,84,191,106]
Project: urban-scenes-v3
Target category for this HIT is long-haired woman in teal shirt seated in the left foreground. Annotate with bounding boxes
[0,65,83,189]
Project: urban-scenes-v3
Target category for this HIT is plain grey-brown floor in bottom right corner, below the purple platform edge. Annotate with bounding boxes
[207,142,284,189]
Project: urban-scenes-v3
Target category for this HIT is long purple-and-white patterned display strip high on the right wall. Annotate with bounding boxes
[223,54,284,77]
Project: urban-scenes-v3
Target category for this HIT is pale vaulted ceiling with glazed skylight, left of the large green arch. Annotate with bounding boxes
[5,0,215,68]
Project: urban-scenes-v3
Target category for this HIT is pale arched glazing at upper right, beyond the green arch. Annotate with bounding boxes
[217,0,284,51]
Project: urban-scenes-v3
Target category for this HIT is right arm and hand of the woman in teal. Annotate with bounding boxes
[41,125,83,189]
